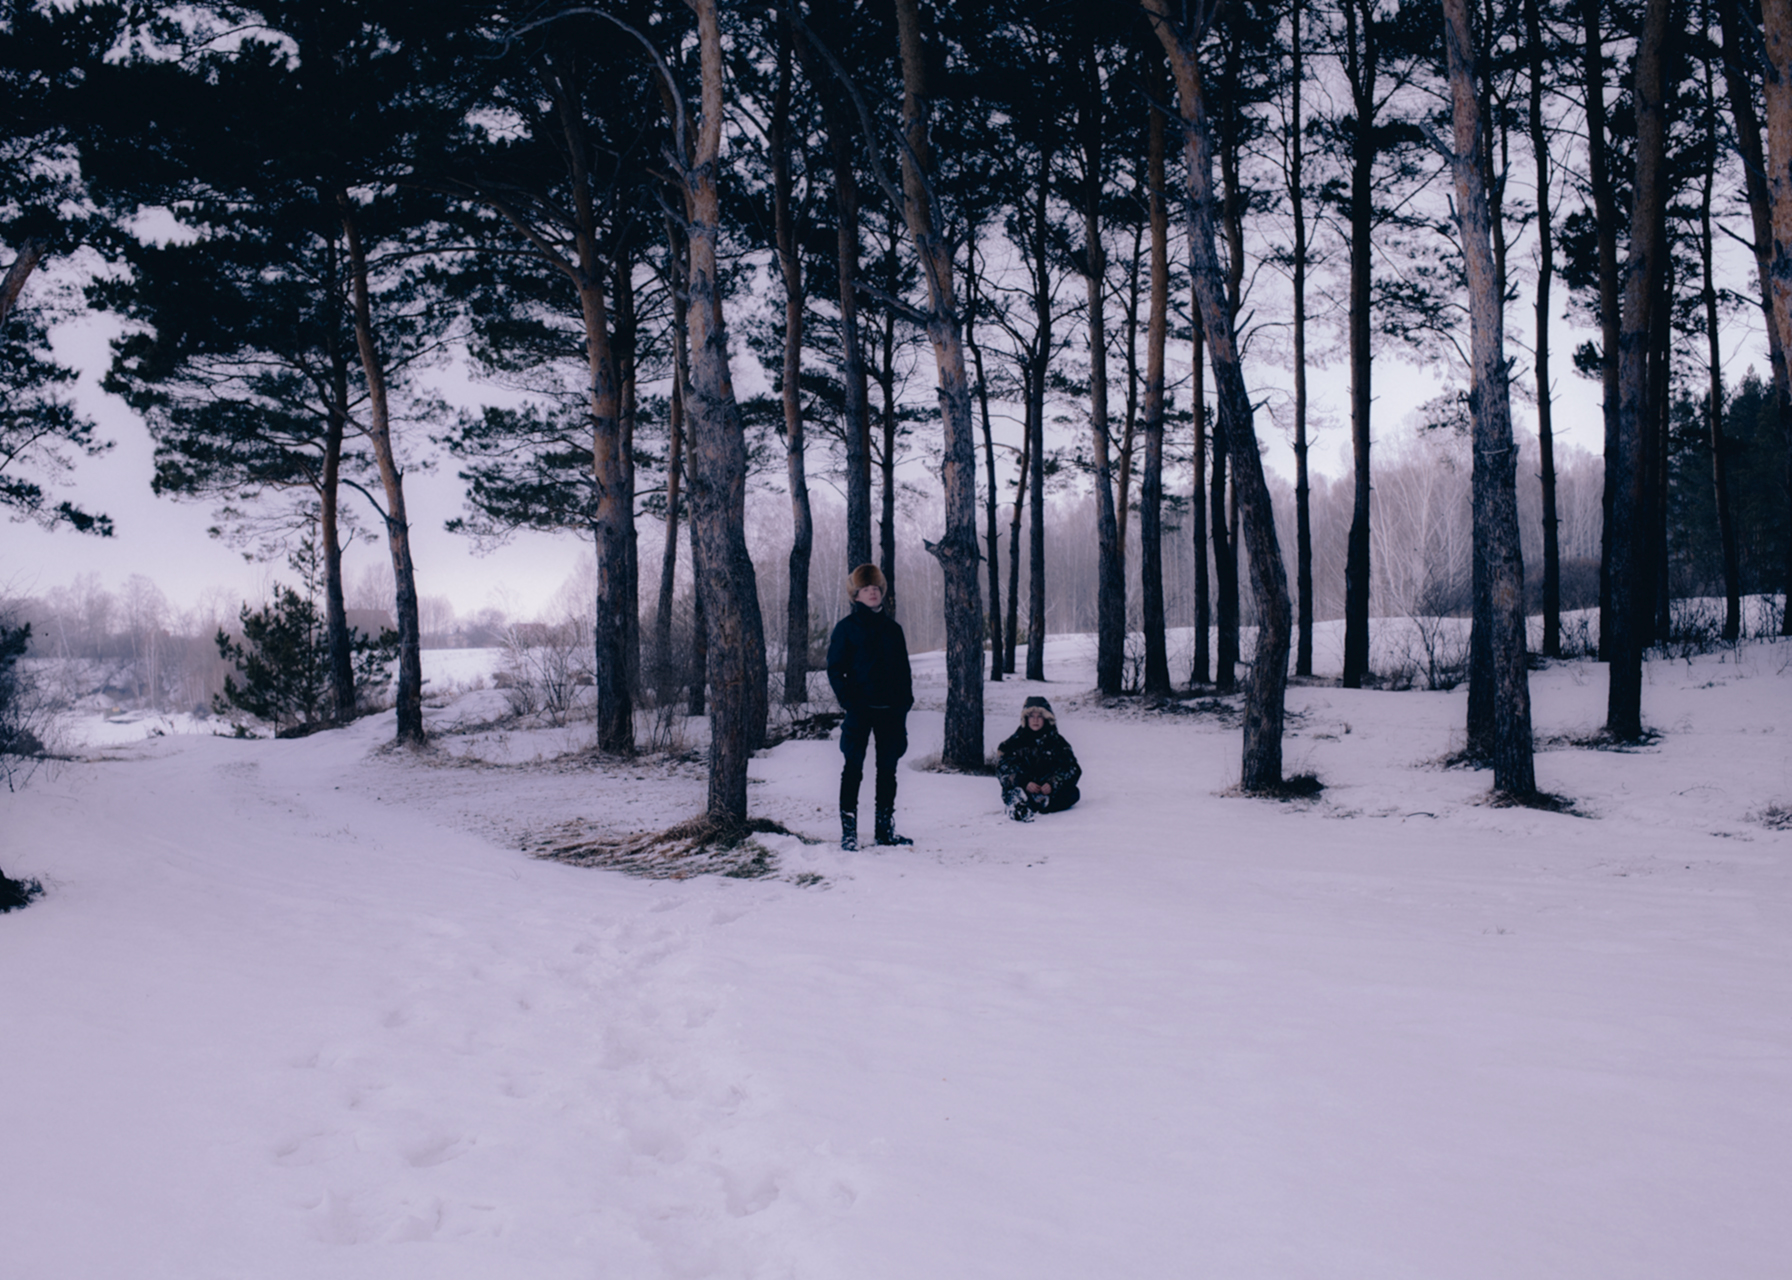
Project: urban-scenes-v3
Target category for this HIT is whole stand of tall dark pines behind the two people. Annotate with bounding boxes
[10,0,1792,821]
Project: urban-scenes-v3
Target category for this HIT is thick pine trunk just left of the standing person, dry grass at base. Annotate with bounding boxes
[686,0,765,825]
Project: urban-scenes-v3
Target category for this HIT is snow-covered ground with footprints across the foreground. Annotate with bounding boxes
[0,638,1792,1280]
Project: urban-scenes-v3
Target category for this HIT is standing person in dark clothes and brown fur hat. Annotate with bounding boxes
[828,565,914,850]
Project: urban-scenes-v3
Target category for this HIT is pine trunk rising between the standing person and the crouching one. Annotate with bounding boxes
[896,0,984,769]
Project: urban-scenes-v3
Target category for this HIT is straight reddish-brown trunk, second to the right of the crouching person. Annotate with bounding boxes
[1138,77,1170,696]
